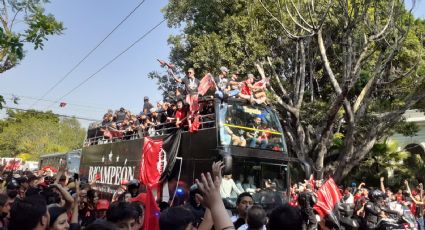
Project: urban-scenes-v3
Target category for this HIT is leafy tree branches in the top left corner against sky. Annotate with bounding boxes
[0,0,64,109]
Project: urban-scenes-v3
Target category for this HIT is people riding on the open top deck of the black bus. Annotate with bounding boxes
[89,67,267,142]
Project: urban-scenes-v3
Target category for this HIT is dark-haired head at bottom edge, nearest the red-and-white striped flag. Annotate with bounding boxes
[268,204,303,230]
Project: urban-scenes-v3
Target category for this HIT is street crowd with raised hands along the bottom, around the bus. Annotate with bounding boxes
[0,162,425,230]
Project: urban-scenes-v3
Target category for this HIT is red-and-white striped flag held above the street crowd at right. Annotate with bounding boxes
[314,178,342,218]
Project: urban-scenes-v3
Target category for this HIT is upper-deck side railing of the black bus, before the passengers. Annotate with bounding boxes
[84,114,215,146]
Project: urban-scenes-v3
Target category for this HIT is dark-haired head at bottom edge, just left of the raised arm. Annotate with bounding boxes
[159,206,194,230]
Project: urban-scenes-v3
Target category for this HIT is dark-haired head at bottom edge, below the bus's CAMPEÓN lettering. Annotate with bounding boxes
[106,202,139,229]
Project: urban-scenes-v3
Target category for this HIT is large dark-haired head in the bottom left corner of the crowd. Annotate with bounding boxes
[8,195,50,230]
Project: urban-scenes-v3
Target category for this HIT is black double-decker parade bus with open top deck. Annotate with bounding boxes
[80,98,309,208]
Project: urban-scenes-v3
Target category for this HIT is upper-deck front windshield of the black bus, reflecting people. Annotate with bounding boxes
[218,100,286,151]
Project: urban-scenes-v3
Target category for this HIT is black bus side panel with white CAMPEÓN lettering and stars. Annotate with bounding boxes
[80,139,143,193]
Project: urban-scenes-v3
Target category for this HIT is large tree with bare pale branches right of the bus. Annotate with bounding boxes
[155,0,425,182]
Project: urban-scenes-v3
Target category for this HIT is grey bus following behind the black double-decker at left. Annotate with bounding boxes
[39,149,81,174]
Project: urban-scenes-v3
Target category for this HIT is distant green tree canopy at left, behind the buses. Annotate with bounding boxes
[0,110,85,159]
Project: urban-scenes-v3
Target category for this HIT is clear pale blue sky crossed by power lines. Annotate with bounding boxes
[0,0,425,127]
